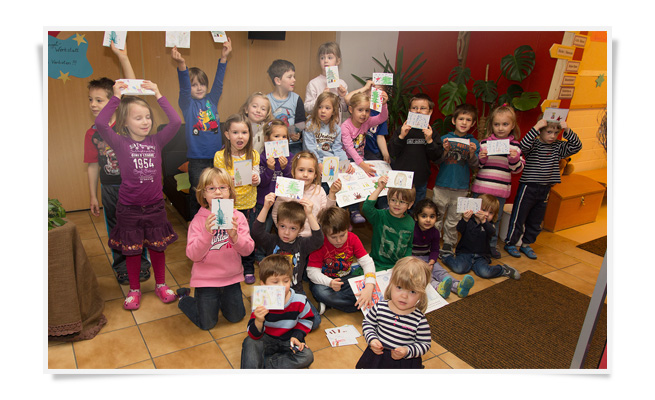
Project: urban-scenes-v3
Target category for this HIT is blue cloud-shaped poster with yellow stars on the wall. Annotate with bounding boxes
[47,33,93,83]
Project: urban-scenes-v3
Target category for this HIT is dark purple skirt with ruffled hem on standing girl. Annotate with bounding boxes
[109,199,177,256]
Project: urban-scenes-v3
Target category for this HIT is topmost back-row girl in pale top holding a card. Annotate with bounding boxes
[305,42,348,119]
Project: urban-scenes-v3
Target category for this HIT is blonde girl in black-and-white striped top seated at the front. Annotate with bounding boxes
[356,256,431,369]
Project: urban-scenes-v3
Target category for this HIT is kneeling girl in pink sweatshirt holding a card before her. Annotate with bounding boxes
[177,168,255,330]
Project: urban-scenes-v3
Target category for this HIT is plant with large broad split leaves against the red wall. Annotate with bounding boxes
[433,45,541,135]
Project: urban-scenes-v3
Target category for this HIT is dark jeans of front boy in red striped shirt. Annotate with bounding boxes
[241,334,314,369]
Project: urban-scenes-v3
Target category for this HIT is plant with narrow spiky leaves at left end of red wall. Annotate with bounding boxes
[351,48,427,133]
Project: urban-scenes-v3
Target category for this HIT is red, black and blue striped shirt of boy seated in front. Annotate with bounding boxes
[248,289,314,342]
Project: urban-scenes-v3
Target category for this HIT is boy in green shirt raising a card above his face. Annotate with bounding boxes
[362,175,416,272]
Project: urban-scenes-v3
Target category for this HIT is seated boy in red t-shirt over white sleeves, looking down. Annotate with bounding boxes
[307,207,376,314]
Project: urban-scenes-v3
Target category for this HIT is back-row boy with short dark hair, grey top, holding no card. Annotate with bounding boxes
[266,60,307,154]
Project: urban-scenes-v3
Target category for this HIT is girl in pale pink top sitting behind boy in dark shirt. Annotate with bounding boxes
[271,150,341,237]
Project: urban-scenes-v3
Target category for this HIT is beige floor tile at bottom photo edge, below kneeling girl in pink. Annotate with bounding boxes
[153,341,232,369]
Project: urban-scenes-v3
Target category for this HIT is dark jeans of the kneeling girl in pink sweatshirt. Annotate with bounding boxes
[177,282,246,330]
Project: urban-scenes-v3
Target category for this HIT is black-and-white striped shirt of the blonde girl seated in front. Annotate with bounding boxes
[362,300,431,358]
